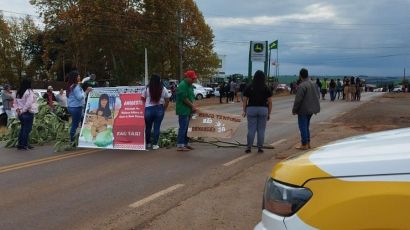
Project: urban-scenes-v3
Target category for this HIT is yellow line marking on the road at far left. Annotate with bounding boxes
[0,149,101,173]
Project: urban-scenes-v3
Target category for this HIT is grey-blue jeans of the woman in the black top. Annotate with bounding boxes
[246,106,268,148]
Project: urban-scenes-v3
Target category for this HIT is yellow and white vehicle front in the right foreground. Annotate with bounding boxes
[255,128,410,230]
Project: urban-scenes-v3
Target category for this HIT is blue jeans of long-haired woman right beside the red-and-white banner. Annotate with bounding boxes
[145,105,165,145]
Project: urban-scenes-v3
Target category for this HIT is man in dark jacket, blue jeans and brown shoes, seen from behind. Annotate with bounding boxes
[292,68,320,150]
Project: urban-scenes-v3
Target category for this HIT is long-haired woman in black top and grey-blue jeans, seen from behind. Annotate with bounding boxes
[242,70,272,153]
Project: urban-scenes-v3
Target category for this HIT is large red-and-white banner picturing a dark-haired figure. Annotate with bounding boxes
[78,87,145,150]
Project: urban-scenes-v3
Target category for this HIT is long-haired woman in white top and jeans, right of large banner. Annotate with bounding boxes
[142,74,171,150]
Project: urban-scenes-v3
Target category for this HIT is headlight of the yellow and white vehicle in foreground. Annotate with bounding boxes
[263,178,312,217]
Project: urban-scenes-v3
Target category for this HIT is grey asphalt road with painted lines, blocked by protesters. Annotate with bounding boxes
[0,93,381,230]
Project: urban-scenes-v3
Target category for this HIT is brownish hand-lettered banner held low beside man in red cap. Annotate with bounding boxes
[188,110,241,138]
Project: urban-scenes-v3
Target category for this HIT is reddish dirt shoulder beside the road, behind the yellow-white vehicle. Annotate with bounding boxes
[141,94,410,229]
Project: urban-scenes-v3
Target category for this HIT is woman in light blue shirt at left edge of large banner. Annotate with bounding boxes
[66,71,92,144]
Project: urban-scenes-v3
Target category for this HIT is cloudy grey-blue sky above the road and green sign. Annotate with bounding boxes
[0,0,410,76]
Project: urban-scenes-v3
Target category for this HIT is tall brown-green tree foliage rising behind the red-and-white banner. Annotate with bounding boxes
[21,0,221,85]
